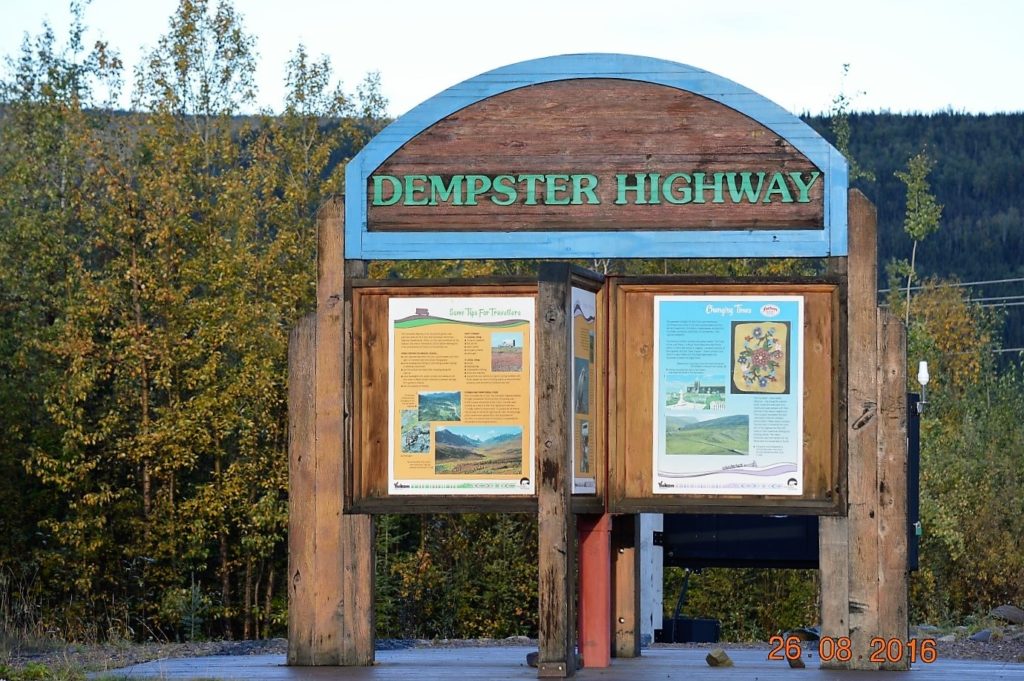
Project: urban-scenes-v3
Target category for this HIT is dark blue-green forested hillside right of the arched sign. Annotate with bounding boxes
[806,113,1024,347]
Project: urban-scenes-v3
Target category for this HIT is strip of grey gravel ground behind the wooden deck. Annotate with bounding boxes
[0,627,1024,672]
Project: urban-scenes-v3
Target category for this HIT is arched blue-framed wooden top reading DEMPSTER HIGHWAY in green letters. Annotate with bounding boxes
[345,54,847,259]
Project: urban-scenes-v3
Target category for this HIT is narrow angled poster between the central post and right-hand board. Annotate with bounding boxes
[569,287,597,495]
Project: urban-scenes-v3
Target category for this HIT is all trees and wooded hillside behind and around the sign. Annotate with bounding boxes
[0,0,1024,641]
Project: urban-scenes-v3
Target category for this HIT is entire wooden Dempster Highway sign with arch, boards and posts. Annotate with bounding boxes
[289,54,908,677]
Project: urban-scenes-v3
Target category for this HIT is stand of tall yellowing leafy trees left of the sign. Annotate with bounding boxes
[0,0,386,638]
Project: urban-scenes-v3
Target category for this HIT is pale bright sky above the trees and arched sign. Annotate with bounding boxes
[0,0,1024,116]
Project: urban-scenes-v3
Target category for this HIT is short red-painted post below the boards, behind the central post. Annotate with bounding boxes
[577,513,611,668]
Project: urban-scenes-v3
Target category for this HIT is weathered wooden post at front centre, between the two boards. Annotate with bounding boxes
[537,263,575,677]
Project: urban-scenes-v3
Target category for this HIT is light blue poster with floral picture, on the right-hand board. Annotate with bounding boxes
[653,296,804,496]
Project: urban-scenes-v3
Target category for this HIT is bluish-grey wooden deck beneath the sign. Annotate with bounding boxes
[94,646,1024,681]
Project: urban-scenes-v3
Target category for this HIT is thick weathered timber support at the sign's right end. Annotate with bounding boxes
[819,190,907,670]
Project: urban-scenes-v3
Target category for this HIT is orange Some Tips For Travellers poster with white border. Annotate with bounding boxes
[388,297,536,495]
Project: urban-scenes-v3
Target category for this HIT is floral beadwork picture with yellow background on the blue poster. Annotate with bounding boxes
[731,322,791,395]
